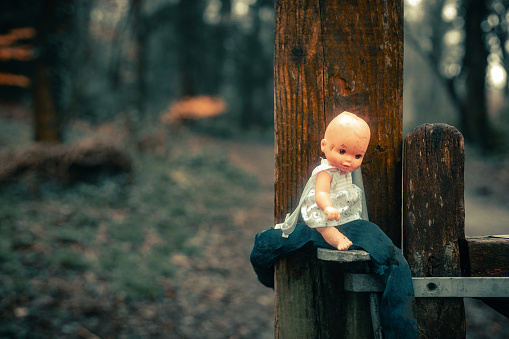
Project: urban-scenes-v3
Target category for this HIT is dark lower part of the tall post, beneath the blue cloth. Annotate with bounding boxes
[275,249,373,339]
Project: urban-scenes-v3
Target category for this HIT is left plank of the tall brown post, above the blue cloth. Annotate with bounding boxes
[274,0,326,230]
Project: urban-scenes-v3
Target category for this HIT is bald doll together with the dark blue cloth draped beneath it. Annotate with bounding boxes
[250,112,417,339]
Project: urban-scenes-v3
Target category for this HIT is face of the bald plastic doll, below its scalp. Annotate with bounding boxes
[321,119,370,172]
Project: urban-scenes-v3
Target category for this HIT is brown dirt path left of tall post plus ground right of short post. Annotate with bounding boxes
[179,137,509,338]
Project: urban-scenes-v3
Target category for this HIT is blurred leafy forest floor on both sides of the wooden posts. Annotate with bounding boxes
[0,105,509,339]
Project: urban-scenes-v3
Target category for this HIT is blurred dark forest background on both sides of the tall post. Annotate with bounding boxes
[0,0,509,150]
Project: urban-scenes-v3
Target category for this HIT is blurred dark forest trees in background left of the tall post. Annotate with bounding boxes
[0,0,274,135]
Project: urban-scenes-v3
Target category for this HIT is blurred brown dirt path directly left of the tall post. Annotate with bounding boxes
[166,140,274,339]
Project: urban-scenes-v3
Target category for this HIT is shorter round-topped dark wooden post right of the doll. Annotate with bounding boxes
[403,124,466,338]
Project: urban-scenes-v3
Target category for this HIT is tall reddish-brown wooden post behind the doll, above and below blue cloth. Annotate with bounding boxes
[274,0,403,339]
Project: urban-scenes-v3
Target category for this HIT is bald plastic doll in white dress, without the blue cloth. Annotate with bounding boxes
[275,112,370,250]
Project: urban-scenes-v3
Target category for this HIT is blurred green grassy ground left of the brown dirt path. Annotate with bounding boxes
[0,120,258,337]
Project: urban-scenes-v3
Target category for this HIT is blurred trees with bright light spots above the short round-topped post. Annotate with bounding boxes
[404,0,509,154]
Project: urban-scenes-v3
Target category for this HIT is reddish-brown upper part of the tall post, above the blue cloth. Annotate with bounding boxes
[274,0,403,244]
